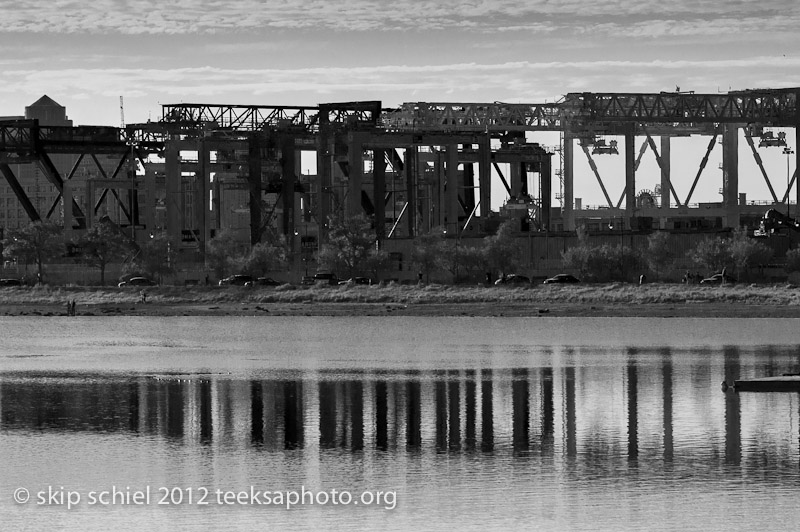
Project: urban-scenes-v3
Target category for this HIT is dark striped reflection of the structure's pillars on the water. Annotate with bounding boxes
[0,347,800,467]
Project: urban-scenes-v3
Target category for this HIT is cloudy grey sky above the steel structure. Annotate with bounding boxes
[0,0,800,204]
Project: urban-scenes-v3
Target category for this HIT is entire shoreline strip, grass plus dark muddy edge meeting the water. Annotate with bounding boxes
[0,283,800,318]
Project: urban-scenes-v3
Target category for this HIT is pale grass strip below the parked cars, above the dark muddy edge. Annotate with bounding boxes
[0,283,800,307]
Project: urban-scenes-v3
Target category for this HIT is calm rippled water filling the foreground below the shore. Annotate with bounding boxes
[0,317,800,530]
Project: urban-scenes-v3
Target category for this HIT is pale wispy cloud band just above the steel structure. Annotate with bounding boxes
[0,56,800,103]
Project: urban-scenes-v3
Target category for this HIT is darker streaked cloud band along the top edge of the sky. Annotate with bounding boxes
[0,0,800,35]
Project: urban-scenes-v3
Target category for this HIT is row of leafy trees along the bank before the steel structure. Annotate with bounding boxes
[0,214,800,284]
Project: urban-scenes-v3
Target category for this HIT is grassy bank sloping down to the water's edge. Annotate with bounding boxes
[0,283,800,316]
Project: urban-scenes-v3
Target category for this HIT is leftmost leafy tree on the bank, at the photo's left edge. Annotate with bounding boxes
[3,220,64,281]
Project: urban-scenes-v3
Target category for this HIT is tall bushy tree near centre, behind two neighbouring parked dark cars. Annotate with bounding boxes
[318,214,377,277]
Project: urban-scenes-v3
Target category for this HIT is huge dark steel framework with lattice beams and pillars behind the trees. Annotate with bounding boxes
[0,88,800,278]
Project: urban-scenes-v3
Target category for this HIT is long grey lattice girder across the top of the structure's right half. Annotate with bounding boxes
[381,88,800,134]
